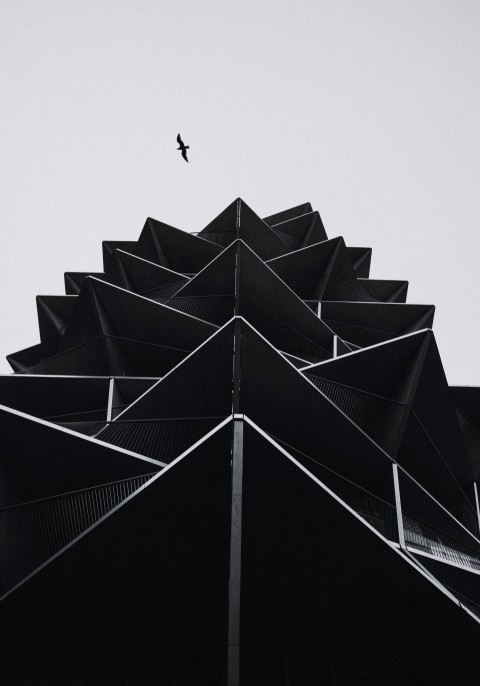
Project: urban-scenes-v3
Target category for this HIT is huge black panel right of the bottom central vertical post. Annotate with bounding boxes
[241,427,478,686]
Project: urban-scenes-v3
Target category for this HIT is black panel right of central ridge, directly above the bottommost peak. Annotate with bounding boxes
[240,322,392,497]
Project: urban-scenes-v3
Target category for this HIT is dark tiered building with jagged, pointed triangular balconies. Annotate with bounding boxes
[0,199,480,686]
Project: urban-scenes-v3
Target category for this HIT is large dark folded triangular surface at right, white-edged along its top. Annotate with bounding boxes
[303,330,478,530]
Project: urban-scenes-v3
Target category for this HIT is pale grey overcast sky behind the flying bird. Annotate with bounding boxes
[0,0,480,385]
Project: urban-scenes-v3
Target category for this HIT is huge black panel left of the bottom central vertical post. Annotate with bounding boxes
[0,425,231,686]
